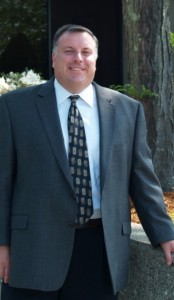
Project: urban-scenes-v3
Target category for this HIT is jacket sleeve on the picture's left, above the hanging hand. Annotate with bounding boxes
[0,95,15,245]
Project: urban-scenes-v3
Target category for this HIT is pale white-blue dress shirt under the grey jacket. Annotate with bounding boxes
[54,79,101,218]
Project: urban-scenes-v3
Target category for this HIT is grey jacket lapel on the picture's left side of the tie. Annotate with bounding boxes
[36,80,73,189]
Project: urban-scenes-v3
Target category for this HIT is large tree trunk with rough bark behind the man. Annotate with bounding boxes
[122,0,174,191]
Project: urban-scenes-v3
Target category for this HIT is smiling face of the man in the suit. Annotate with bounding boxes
[52,32,97,93]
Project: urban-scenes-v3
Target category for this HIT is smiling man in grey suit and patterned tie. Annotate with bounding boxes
[0,25,174,300]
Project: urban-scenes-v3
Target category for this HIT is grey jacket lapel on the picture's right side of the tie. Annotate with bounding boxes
[94,84,114,192]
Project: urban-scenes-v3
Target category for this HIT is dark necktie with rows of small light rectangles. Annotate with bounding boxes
[68,95,93,224]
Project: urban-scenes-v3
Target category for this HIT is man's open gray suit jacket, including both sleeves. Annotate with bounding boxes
[0,79,174,292]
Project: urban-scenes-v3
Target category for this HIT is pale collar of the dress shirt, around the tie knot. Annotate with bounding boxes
[54,78,96,107]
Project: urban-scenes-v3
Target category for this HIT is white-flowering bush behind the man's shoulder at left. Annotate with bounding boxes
[0,70,45,95]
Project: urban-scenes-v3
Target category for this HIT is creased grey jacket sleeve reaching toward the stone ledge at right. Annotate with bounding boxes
[130,104,174,246]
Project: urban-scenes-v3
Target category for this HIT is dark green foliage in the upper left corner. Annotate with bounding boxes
[0,0,47,55]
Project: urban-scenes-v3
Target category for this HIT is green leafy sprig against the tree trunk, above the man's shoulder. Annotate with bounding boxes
[110,83,158,101]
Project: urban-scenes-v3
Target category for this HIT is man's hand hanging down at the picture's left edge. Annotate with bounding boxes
[0,246,10,283]
